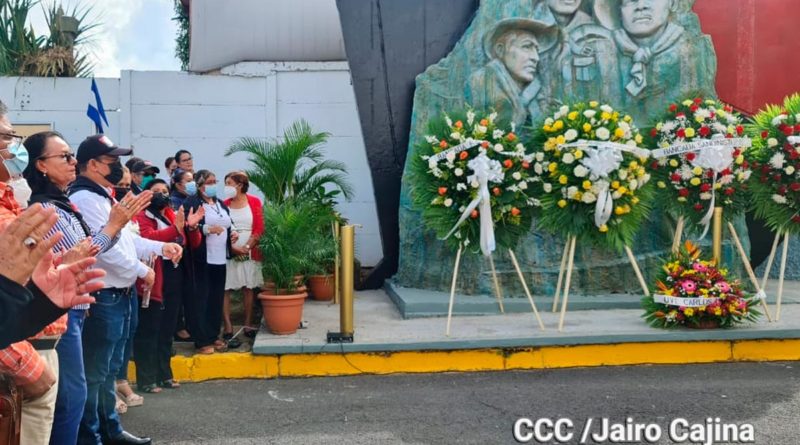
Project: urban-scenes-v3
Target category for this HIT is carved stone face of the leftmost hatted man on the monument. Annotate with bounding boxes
[495,30,539,84]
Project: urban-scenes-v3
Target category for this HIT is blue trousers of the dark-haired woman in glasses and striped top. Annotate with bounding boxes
[50,309,86,445]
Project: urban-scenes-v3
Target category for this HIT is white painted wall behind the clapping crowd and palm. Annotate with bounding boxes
[0,62,382,266]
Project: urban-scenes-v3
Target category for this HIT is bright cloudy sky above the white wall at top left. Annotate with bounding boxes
[30,0,180,77]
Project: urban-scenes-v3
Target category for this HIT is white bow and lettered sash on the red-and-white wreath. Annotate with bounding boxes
[652,134,752,239]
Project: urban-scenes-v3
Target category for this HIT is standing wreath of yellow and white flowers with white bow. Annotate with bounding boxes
[533,101,652,250]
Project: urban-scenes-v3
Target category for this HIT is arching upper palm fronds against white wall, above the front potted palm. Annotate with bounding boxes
[225,120,353,205]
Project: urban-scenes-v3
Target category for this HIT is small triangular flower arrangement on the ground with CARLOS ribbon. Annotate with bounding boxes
[642,241,761,328]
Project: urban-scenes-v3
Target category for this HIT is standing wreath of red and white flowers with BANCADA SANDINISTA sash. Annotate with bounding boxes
[649,97,751,227]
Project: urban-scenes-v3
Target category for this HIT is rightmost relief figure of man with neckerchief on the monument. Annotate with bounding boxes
[594,0,717,119]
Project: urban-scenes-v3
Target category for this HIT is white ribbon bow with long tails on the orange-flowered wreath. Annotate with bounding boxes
[443,151,504,256]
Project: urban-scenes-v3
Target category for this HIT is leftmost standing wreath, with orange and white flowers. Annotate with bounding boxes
[408,110,539,251]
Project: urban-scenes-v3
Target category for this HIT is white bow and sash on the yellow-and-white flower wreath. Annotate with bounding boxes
[559,140,650,228]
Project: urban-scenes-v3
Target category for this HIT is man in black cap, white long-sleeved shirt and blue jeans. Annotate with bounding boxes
[70,135,183,445]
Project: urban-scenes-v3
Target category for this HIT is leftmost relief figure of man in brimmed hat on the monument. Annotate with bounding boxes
[465,18,557,125]
